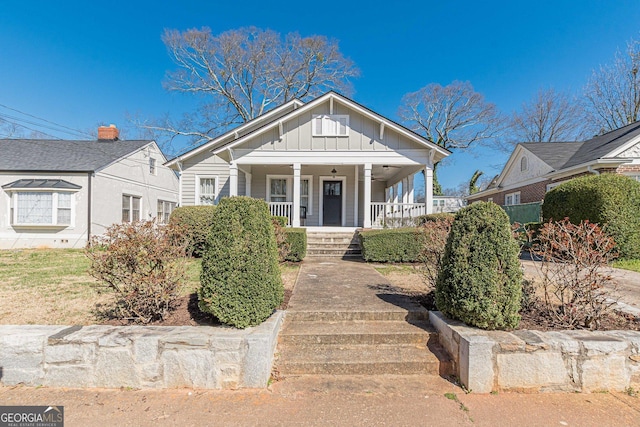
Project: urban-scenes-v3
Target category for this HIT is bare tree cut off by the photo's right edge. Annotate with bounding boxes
[584,40,640,133]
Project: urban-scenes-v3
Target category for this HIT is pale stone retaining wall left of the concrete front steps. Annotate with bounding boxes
[0,311,284,389]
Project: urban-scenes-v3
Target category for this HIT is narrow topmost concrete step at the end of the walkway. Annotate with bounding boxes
[287,310,429,323]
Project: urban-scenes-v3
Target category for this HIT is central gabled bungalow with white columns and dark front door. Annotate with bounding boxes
[166,92,450,228]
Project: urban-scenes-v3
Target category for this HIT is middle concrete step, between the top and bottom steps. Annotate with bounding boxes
[280,321,436,346]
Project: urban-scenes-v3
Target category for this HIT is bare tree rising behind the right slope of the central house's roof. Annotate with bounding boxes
[398,81,504,195]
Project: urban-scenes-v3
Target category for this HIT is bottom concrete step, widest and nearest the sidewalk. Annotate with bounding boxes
[278,344,448,375]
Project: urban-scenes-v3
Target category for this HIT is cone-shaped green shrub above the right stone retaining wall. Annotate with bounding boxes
[436,202,522,329]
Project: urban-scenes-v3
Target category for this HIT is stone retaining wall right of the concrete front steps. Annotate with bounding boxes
[429,311,640,393]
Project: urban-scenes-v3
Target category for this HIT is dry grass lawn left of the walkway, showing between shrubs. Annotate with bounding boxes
[0,249,299,325]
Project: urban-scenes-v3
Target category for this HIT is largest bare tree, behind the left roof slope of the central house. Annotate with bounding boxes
[151,27,359,147]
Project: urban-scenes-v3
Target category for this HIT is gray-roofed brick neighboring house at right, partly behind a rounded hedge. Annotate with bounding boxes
[467,122,640,206]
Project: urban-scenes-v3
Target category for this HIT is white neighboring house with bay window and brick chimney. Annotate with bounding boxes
[0,127,179,249]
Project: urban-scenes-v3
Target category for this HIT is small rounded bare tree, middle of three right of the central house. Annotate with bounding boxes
[509,88,586,144]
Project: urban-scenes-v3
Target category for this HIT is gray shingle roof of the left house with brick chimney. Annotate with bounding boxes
[0,139,152,172]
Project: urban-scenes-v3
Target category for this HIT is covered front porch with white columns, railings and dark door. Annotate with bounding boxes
[229,159,433,229]
